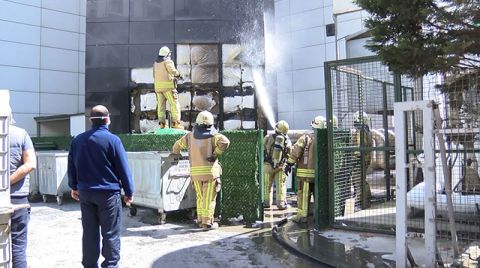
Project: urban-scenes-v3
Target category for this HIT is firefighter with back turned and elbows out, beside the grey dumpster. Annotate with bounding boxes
[172,111,230,230]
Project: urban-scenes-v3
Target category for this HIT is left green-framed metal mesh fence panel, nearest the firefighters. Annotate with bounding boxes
[326,58,398,231]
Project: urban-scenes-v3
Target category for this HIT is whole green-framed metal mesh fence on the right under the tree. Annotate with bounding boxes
[325,57,480,262]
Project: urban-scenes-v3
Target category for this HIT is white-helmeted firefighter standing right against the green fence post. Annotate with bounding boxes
[285,116,327,223]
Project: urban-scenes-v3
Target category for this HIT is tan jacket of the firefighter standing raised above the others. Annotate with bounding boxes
[153,59,180,92]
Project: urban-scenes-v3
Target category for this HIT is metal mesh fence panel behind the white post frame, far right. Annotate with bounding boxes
[407,71,480,264]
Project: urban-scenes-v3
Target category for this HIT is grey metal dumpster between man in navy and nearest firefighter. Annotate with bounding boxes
[128,152,196,224]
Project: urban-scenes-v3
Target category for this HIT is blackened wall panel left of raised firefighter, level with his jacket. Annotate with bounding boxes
[85,68,129,93]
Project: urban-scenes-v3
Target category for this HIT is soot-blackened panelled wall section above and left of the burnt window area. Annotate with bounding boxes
[85,0,271,133]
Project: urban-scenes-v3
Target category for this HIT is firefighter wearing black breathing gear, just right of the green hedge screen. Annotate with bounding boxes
[263,120,292,210]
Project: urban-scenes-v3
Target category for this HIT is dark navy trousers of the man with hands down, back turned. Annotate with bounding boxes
[80,191,122,268]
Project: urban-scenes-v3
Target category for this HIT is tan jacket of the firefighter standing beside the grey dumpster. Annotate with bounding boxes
[172,127,230,181]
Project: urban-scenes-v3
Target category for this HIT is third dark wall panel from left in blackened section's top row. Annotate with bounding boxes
[175,0,220,20]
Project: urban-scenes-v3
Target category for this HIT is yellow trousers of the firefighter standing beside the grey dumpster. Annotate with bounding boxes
[193,178,221,225]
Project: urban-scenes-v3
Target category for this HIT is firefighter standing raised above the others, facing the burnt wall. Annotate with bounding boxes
[153,47,183,129]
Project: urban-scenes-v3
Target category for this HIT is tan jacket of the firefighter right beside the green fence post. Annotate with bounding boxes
[287,133,315,182]
